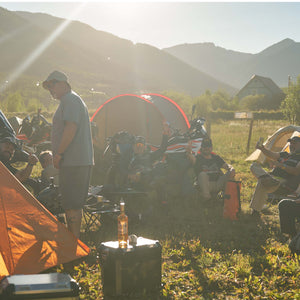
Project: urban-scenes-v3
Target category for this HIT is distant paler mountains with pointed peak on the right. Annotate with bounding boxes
[163,39,300,89]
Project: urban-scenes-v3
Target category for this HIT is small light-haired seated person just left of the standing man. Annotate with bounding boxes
[39,151,59,187]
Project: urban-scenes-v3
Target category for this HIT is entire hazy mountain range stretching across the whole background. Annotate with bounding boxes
[0,7,300,96]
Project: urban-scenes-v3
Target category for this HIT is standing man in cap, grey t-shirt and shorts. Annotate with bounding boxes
[43,71,94,238]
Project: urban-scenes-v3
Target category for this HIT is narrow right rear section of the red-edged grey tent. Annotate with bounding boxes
[141,93,190,133]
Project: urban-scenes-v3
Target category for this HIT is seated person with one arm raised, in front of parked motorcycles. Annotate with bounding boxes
[128,122,170,187]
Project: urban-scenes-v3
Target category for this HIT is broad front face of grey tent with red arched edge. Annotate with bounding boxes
[91,94,165,149]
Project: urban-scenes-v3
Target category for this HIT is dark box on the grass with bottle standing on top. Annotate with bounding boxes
[98,237,161,299]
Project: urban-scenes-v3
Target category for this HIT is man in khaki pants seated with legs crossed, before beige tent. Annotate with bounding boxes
[250,136,300,215]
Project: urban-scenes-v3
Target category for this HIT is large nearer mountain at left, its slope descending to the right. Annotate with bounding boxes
[0,7,237,101]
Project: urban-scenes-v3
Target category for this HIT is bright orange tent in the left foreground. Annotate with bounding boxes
[0,162,90,279]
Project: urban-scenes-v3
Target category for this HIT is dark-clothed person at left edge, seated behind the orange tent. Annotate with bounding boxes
[0,137,38,183]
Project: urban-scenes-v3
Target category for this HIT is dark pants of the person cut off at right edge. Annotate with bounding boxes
[278,199,300,236]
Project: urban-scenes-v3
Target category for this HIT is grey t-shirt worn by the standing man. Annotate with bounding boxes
[52,91,94,166]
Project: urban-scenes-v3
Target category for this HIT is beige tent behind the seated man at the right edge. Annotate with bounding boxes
[246,125,300,164]
